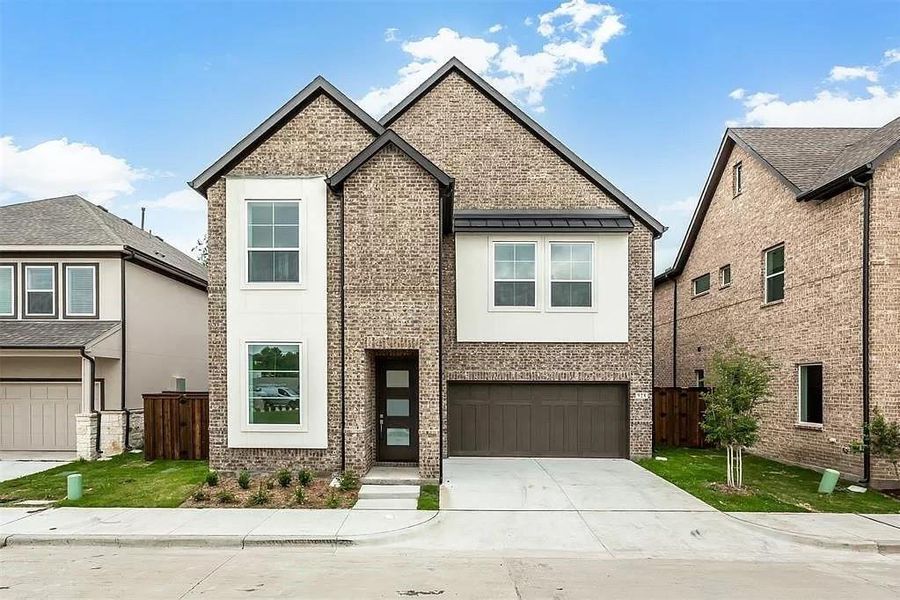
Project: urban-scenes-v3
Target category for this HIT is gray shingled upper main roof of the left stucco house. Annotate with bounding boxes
[0,196,206,283]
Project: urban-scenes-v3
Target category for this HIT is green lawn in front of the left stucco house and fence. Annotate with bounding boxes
[0,453,208,508]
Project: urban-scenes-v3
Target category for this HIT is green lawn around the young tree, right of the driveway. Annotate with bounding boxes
[640,448,900,513]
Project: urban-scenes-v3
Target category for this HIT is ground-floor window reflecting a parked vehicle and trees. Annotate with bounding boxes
[247,344,300,425]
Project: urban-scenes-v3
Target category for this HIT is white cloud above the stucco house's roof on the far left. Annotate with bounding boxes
[0,137,148,204]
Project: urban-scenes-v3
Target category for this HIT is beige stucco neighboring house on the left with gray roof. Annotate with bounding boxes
[0,196,207,459]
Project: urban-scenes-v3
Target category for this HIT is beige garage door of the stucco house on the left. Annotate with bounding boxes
[0,382,81,450]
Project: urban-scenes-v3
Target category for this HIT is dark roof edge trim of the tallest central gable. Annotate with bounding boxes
[380,57,666,237]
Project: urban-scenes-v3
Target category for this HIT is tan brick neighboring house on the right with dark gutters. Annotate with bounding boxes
[654,119,900,484]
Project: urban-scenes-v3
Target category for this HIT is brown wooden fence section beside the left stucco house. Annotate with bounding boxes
[144,392,209,460]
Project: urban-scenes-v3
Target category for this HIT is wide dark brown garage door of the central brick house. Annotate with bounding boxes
[448,383,628,458]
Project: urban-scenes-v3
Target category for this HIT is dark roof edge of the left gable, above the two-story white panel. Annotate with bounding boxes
[188,75,384,194]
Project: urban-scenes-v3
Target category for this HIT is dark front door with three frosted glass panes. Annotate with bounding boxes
[375,359,419,462]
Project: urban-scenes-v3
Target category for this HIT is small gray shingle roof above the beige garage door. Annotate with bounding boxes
[0,321,119,348]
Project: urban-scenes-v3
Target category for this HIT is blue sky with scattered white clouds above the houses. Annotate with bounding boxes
[0,0,900,268]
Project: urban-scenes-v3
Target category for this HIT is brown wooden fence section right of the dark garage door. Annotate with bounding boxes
[653,388,706,448]
